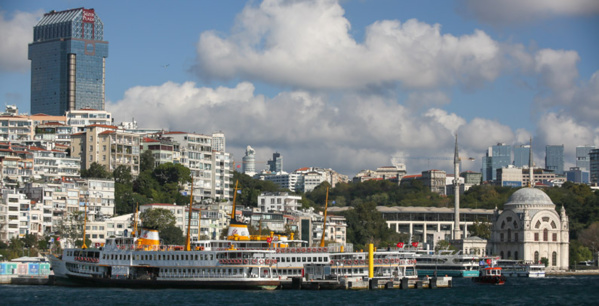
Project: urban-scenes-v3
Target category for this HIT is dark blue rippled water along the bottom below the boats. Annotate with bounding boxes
[0,276,599,306]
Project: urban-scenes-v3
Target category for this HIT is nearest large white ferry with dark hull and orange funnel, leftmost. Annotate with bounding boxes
[49,229,281,290]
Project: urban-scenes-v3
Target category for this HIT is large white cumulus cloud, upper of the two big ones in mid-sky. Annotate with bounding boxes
[193,0,502,90]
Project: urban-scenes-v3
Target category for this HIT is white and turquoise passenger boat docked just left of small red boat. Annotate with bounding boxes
[416,250,479,277]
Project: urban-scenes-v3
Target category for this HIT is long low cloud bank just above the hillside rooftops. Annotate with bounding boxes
[107,82,513,175]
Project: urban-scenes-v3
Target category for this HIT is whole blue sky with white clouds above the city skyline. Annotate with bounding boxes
[0,0,599,178]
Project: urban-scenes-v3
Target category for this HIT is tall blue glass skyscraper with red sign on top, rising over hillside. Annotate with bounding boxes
[28,8,108,116]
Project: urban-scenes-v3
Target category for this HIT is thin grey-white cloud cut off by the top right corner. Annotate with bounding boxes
[458,0,599,26]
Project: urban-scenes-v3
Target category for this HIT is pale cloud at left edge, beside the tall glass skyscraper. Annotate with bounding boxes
[0,11,42,72]
